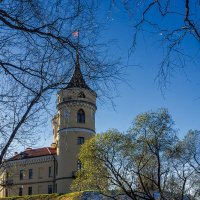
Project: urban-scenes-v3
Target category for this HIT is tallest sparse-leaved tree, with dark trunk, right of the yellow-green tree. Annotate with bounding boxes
[126,109,178,191]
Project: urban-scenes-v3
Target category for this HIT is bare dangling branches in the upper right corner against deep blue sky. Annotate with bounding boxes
[111,0,200,89]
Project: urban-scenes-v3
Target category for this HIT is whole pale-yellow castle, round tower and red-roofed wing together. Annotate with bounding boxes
[0,59,96,197]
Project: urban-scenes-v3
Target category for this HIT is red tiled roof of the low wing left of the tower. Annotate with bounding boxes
[8,147,56,161]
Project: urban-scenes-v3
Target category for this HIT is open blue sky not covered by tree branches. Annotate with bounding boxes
[40,0,200,146]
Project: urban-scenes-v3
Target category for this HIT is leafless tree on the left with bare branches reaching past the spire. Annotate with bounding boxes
[0,0,120,165]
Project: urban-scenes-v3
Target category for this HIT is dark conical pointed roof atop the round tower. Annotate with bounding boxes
[65,53,92,91]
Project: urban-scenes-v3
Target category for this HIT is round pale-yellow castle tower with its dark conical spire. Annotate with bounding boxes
[53,55,96,193]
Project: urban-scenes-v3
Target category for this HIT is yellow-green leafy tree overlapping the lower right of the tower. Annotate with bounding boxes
[71,129,134,195]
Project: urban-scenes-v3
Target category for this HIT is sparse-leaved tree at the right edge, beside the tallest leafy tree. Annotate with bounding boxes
[167,130,200,199]
